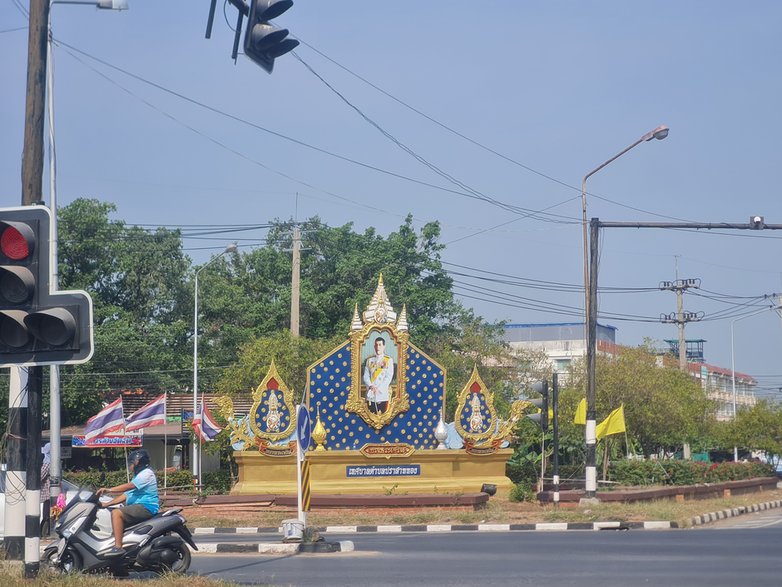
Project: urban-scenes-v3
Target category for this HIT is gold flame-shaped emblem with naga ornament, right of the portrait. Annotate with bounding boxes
[454,365,532,454]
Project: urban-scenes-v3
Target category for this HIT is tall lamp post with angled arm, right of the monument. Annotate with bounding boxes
[581,125,668,499]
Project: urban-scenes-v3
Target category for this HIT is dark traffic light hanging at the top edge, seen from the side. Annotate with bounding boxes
[244,0,299,73]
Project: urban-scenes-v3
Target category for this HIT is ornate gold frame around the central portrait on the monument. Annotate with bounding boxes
[345,322,410,430]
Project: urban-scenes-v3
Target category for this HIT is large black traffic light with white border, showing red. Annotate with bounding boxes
[0,206,93,367]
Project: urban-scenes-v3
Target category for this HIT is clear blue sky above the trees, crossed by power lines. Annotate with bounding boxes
[0,0,782,396]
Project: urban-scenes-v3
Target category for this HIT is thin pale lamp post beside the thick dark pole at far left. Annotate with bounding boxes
[46,0,128,506]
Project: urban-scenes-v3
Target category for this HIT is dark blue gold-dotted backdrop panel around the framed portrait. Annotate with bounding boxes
[307,342,445,450]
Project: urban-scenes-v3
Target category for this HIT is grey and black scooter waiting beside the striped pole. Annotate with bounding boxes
[43,489,198,576]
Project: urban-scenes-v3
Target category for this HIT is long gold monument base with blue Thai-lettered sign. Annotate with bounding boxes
[231,448,513,495]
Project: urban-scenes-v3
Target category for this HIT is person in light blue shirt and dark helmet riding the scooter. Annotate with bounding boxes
[96,449,160,556]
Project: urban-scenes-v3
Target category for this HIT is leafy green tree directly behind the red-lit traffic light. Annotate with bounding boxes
[58,198,191,423]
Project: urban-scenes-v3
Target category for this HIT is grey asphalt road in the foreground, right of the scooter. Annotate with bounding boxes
[191,512,782,587]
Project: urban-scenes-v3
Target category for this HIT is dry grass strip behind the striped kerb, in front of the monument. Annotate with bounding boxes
[178,489,782,528]
